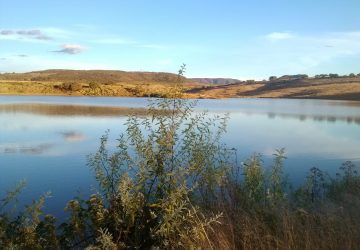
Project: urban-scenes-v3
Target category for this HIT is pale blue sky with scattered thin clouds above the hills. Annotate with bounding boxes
[0,0,360,80]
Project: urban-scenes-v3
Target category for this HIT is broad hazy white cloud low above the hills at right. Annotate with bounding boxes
[253,31,360,74]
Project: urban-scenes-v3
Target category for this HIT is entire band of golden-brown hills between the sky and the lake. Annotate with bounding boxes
[0,70,360,100]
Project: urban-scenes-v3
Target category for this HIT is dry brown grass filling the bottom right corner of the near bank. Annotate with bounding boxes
[205,209,360,250]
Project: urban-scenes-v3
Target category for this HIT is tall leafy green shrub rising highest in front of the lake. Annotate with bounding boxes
[78,91,228,248]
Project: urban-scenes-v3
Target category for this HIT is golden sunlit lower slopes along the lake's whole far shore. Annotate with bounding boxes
[0,77,360,101]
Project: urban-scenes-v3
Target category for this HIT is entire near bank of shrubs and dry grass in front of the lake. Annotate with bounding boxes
[0,95,360,249]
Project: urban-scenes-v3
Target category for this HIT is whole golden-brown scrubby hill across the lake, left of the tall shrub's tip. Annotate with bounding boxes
[0,69,204,97]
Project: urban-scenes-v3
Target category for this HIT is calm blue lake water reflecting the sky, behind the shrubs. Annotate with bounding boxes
[0,96,360,216]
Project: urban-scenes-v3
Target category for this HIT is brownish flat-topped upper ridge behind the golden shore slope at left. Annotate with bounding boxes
[0,69,185,84]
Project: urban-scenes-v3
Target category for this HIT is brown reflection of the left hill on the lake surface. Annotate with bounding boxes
[0,103,146,117]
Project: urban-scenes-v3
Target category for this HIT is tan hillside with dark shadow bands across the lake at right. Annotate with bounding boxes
[187,76,360,101]
